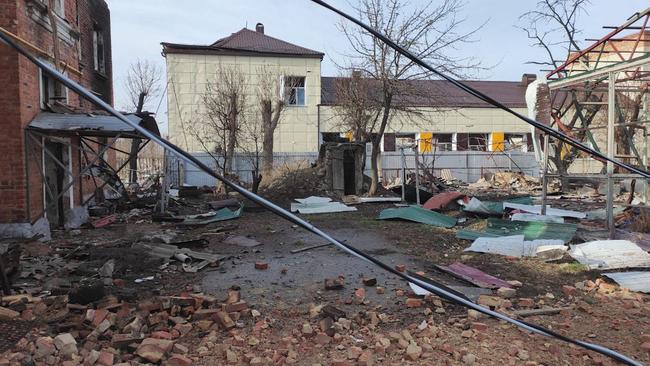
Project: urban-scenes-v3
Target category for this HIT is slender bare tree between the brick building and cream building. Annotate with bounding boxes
[124,59,162,183]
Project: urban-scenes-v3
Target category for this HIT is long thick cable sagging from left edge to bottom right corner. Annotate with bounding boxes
[0,22,642,366]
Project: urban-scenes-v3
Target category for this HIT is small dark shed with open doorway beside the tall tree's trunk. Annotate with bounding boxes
[319,142,366,195]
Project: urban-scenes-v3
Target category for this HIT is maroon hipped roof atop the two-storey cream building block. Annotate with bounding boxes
[162,28,325,59]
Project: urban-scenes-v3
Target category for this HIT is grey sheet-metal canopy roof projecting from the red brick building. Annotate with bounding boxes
[28,112,160,137]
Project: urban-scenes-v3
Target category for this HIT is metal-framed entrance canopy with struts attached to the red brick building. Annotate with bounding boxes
[25,112,159,225]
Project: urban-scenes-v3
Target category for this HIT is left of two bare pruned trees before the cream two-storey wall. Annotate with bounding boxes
[189,65,248,183]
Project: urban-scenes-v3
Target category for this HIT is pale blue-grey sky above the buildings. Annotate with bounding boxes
[107,0,648,130]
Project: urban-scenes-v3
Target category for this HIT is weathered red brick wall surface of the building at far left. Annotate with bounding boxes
[0,0,113,223]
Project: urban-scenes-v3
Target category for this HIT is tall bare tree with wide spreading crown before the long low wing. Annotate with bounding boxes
[339,0,482,195]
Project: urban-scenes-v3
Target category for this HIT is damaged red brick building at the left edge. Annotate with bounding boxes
[0,0,113,237]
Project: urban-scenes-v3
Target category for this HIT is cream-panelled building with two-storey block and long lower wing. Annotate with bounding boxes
[162,24,535,153]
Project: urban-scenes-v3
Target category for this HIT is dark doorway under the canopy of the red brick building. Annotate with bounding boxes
[43,140,65,227]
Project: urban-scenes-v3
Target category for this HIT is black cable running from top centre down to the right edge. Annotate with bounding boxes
[310,0,650,178]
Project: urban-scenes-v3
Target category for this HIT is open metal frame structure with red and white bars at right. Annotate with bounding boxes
[542,8,650,238]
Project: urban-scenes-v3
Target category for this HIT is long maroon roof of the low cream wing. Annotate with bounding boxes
[321,77,527,108]
